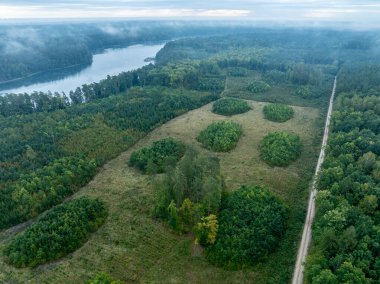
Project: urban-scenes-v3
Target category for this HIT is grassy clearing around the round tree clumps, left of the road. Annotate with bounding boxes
[0,97,320,283]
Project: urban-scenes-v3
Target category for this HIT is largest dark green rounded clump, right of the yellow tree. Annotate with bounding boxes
[206,186,287,269]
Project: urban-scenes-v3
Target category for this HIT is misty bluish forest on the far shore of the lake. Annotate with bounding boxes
[0,21,268,85]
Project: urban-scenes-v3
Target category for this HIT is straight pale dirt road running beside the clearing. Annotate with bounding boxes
[292,77,336,284]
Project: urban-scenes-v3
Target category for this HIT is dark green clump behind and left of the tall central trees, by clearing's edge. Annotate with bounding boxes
[128,138,186,173]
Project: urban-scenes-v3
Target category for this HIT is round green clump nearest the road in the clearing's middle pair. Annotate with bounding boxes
[260,132,302,167]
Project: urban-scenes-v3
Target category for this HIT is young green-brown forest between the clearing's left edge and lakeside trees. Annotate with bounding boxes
[0,87,217,228]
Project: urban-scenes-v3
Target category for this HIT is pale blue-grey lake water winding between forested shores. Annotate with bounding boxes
[0,44,164,94]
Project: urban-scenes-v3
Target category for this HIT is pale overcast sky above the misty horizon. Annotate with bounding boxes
[0,0,380,24]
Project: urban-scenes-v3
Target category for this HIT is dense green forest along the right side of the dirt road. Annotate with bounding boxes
[306,65,380,284]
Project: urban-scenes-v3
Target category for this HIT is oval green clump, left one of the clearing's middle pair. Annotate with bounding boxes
[197,121,243,152]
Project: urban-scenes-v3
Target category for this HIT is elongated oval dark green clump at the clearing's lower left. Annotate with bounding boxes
[4,198,107,267]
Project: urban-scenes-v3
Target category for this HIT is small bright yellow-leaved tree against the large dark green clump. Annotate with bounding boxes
[195,214,218,246]
